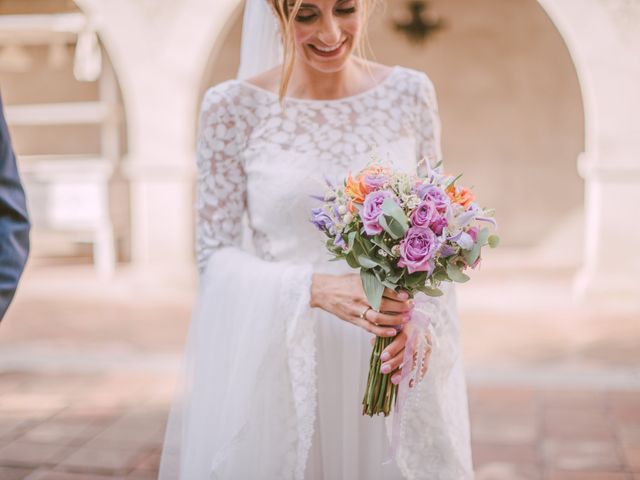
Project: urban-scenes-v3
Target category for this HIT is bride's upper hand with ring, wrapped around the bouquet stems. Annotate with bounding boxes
[309,273,413,337]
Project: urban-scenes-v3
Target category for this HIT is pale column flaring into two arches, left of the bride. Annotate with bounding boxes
[78,0,241,270]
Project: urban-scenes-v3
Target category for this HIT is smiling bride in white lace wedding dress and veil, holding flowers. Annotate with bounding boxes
[160,0,473,480]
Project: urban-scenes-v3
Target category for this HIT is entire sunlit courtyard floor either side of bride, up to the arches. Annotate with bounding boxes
[0,268,640,480]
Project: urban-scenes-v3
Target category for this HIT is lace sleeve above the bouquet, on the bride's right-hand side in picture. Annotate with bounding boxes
[416,74,442,175]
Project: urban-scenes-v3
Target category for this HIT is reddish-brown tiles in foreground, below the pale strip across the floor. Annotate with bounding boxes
[0,373,640,480]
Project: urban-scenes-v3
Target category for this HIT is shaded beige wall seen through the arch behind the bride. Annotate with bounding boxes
[203,0,584,248]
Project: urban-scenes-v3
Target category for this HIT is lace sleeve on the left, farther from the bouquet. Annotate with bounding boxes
[196,85,246,274]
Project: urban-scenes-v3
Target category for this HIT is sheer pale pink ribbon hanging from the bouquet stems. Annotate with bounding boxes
[383,302,435,465]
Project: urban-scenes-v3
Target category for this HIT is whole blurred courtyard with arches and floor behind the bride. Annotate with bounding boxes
[0,0,640,480]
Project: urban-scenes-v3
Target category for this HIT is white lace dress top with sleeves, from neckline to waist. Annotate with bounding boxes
[196,67,441,271]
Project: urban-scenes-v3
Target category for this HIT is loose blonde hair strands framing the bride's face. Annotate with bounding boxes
[271,0,376,101]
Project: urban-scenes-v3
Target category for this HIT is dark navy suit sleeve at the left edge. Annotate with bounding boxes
[0,93,30,320]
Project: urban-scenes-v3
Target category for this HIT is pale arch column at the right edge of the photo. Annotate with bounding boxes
[539,0,640,302]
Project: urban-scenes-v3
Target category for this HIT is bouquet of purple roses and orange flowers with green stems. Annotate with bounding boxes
[311,160,499,416]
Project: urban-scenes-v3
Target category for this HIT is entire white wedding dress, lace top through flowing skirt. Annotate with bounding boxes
[161,67,472,480]
